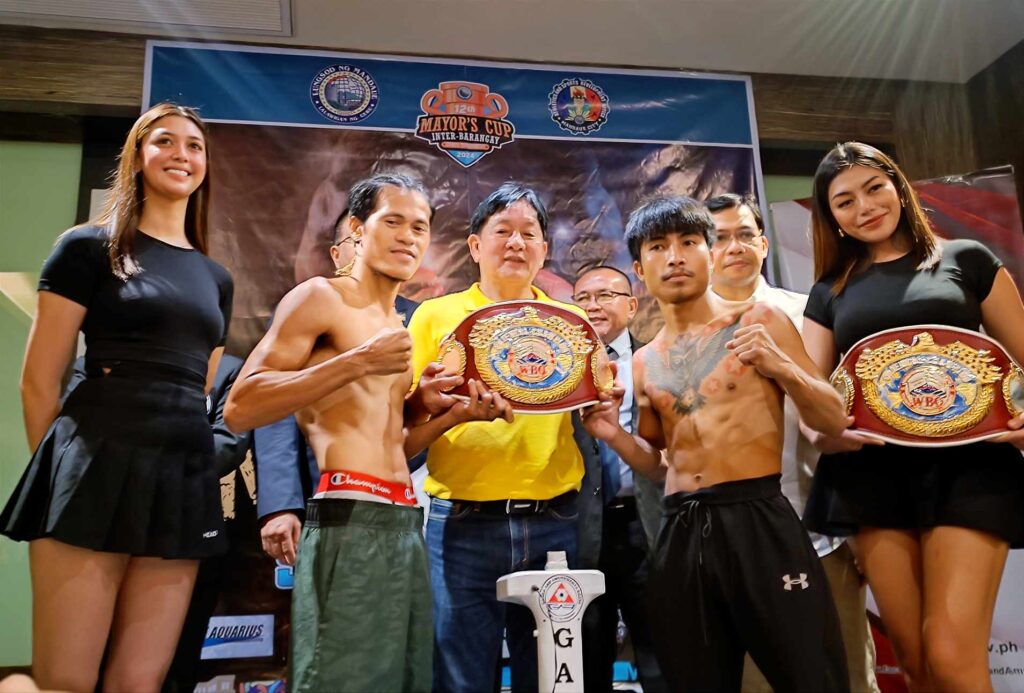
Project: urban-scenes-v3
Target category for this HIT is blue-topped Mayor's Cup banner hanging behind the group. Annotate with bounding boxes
[143,42,764,687]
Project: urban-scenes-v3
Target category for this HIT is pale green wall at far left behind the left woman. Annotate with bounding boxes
[0,141,82,666]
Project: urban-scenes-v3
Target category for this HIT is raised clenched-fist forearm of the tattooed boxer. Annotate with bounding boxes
[726,304,849,435]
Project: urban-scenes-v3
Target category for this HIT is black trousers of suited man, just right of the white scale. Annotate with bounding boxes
[583,497,669,693]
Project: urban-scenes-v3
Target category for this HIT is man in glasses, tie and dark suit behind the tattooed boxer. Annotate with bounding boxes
[572,266,667,693]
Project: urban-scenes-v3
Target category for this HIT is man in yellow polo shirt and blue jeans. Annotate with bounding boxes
[409,183,586,693]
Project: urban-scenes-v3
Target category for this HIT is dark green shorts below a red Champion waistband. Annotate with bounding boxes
[288,499,433,693]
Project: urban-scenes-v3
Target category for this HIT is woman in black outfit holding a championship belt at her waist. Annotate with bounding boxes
[804,142,1024,691]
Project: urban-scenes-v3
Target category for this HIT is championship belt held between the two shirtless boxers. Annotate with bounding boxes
[437,301,613,414]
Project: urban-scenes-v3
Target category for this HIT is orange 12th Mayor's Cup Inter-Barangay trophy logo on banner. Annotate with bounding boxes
[416,82,515,168]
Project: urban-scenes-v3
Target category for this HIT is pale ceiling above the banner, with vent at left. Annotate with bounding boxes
[0,0,1024,82]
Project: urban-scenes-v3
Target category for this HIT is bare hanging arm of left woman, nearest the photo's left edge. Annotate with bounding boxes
[20,291,86,450]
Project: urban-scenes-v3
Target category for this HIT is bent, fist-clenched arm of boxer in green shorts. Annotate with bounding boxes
[224,277,412,431]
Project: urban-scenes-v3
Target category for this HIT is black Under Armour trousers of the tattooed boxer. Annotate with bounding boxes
[648,475,849,693]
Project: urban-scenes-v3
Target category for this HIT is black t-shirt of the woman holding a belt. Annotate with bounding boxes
[804,241,1002,353]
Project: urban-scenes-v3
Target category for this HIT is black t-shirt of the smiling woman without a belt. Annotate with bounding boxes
[39,226,234,378]
